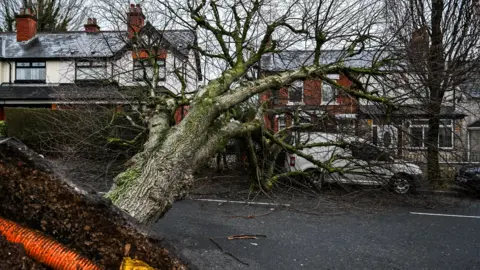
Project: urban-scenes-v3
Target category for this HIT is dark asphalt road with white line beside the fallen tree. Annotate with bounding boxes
[154,196,480,269]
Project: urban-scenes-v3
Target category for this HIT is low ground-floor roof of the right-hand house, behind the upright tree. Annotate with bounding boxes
[360,104,466,118]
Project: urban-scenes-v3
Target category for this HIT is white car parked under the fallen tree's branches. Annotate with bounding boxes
[286,133,422,194]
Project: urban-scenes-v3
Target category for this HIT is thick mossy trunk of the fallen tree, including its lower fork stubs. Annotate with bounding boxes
[106,99,259,223]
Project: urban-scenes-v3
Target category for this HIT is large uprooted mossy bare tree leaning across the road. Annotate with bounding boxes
[82,0,402,222]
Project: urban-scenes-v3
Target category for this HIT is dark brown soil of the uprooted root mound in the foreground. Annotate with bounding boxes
[0,140,187,269]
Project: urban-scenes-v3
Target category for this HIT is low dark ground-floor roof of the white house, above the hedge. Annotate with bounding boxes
[0,84,125,101]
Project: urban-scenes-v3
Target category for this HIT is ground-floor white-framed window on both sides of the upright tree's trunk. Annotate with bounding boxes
[409,119,453,148]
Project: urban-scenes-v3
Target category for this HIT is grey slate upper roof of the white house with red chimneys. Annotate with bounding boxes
[0,30,195,59]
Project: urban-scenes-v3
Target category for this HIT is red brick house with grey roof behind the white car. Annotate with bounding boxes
[259,50,371,134]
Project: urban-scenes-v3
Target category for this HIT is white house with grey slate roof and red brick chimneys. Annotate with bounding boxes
[0,4,202,119]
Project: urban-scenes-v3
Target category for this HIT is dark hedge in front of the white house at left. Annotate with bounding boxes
[6,107,142,158]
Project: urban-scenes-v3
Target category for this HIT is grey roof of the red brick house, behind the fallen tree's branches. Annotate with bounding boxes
[260,50,386,72]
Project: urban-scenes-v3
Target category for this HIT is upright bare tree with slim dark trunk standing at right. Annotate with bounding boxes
[385,0,480,182]
